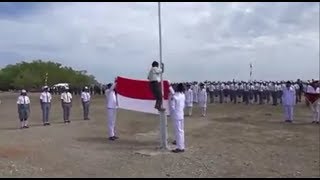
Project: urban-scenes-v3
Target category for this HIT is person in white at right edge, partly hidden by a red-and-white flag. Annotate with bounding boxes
[307,82,320,124]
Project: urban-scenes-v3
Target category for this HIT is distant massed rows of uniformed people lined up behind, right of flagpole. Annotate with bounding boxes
[171,80,310,106]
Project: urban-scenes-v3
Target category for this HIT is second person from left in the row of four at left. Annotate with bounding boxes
[40,86,52,126]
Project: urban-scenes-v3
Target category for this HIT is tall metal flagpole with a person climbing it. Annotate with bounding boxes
[158,2,168,149]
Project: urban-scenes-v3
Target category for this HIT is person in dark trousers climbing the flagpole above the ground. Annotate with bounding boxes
[148,61,165,111]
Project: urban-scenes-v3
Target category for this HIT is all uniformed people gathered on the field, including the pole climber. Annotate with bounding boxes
[7,61,320,153]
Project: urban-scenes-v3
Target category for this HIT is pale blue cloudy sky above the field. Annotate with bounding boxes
[0,2,320,83]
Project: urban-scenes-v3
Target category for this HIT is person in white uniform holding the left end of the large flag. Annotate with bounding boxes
[105,81,118,141]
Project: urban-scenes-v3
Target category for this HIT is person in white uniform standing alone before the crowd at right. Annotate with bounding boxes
[282,81,296,123]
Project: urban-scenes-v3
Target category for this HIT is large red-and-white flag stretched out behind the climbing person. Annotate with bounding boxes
[116,76,169,115]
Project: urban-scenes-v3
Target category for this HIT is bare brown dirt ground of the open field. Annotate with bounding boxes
[0,93,320,177]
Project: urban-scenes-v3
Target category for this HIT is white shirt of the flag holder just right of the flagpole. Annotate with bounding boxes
[171,93,186,120]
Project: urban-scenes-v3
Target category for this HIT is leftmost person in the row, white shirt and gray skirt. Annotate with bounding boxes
[17,89,30,129]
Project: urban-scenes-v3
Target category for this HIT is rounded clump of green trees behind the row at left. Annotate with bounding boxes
[0,60,97,91]
